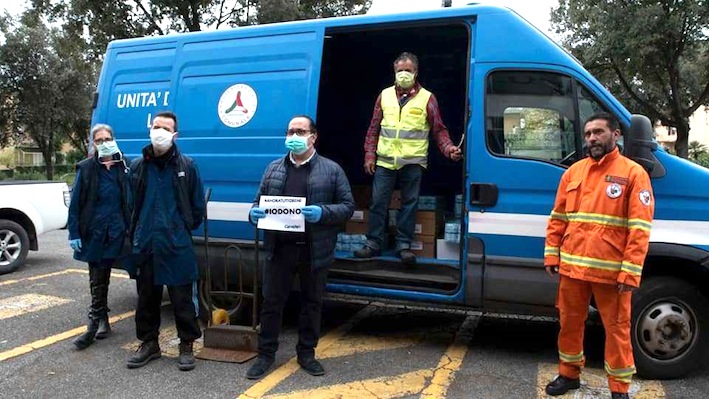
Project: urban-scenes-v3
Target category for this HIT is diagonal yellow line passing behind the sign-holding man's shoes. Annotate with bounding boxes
[239,305,376,399]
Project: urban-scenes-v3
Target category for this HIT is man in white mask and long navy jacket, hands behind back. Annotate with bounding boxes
[126,111,206,371]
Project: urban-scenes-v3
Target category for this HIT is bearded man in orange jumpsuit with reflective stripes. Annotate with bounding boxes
[544,113,654,399]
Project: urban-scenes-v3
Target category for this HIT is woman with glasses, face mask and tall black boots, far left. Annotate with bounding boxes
[67,124,128,350]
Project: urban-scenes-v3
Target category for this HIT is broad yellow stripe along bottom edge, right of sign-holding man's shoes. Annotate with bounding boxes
[266,369,433,399]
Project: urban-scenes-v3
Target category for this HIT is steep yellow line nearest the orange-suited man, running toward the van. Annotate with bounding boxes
[421,316,480,399]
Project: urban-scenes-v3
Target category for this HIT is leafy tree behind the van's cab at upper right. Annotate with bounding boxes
[552,0,709,158]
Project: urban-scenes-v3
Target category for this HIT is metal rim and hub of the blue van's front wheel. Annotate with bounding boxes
[638,302,697,360]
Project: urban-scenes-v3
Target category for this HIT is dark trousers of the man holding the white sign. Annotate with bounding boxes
[258,244,327,359]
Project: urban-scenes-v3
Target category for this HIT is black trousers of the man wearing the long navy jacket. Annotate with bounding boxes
[135,259,202,342]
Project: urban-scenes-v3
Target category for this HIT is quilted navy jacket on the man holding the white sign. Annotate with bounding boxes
[253,154,355,269]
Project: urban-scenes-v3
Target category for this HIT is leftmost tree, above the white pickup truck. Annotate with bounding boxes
[0,11,93,180]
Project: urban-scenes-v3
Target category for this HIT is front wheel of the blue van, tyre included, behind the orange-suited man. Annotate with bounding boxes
[630,276,709,379]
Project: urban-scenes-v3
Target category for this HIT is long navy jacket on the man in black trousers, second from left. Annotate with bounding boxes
[128,145,206,285]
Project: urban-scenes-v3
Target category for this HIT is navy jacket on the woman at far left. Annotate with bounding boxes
[67,156,128,263]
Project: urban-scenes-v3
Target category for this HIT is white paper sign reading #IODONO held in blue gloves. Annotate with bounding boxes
[258,195,305,232]
